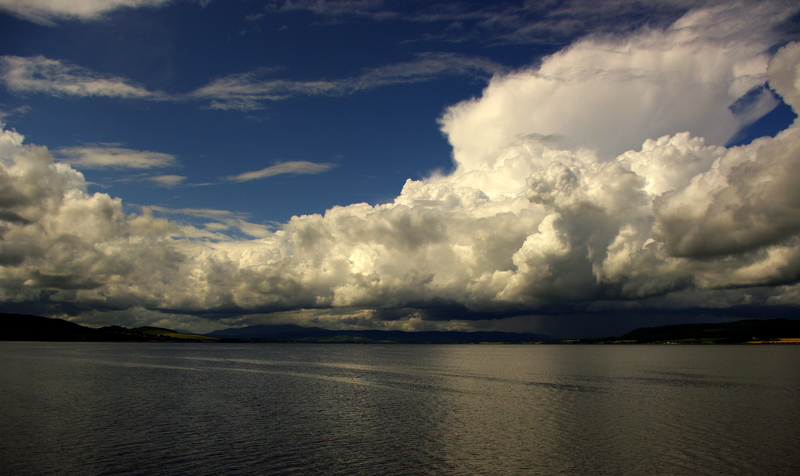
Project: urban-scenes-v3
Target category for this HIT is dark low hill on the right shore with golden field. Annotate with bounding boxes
[588,319,800,344]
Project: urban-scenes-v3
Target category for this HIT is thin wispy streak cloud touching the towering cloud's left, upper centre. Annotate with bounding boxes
[189,53,504,111]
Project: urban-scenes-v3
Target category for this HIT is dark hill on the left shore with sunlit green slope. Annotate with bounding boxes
[0,313,221,342]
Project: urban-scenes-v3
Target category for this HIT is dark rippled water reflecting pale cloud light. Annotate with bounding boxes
[0,342,800,475]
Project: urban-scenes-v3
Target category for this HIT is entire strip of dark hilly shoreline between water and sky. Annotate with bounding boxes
[0,313,800,344]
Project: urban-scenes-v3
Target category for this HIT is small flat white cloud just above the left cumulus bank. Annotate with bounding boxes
[56,144,178,170]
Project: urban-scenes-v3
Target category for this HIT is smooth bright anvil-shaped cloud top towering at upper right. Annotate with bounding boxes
[442,6,785,165]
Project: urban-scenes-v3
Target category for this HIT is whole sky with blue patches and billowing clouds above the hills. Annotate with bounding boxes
[0,0,800,337]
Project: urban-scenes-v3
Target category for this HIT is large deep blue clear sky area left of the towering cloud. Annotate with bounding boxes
[2,1,564,223]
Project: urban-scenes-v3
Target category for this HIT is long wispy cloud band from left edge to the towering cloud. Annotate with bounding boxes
[0,53,506,111]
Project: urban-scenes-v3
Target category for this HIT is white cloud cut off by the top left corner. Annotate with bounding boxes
[0,0,177,26]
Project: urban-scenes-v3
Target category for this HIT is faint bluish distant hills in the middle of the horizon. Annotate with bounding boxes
[206,324,550,344]
